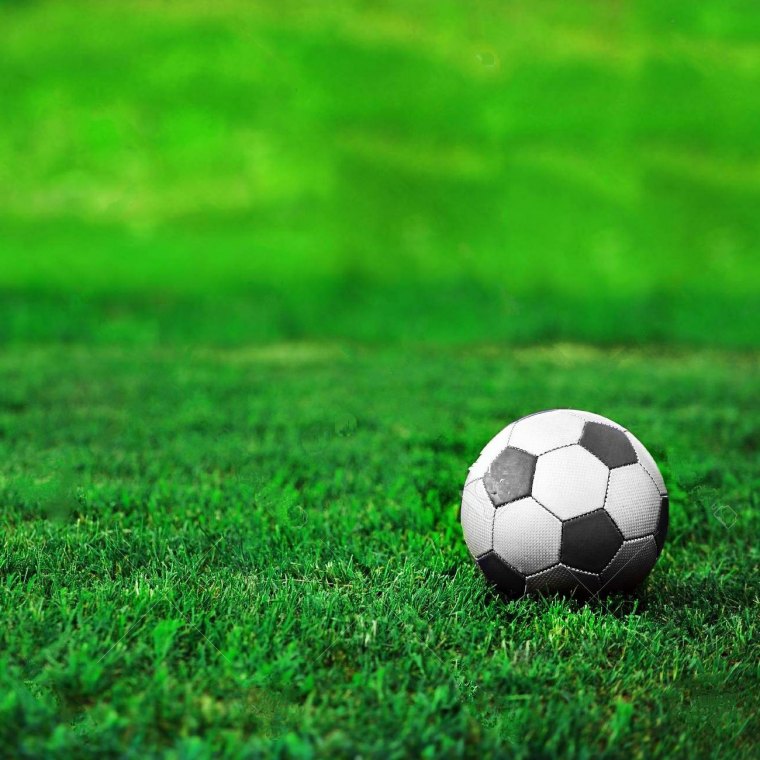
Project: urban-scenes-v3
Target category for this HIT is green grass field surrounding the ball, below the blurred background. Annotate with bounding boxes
[0,344,760,757]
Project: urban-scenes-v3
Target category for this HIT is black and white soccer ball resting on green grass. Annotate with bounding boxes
[461,409,668,596]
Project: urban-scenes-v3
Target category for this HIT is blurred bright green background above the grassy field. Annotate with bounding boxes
[0,0,760,347]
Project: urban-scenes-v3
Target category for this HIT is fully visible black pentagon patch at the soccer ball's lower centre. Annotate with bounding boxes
[560,509,623,573]
